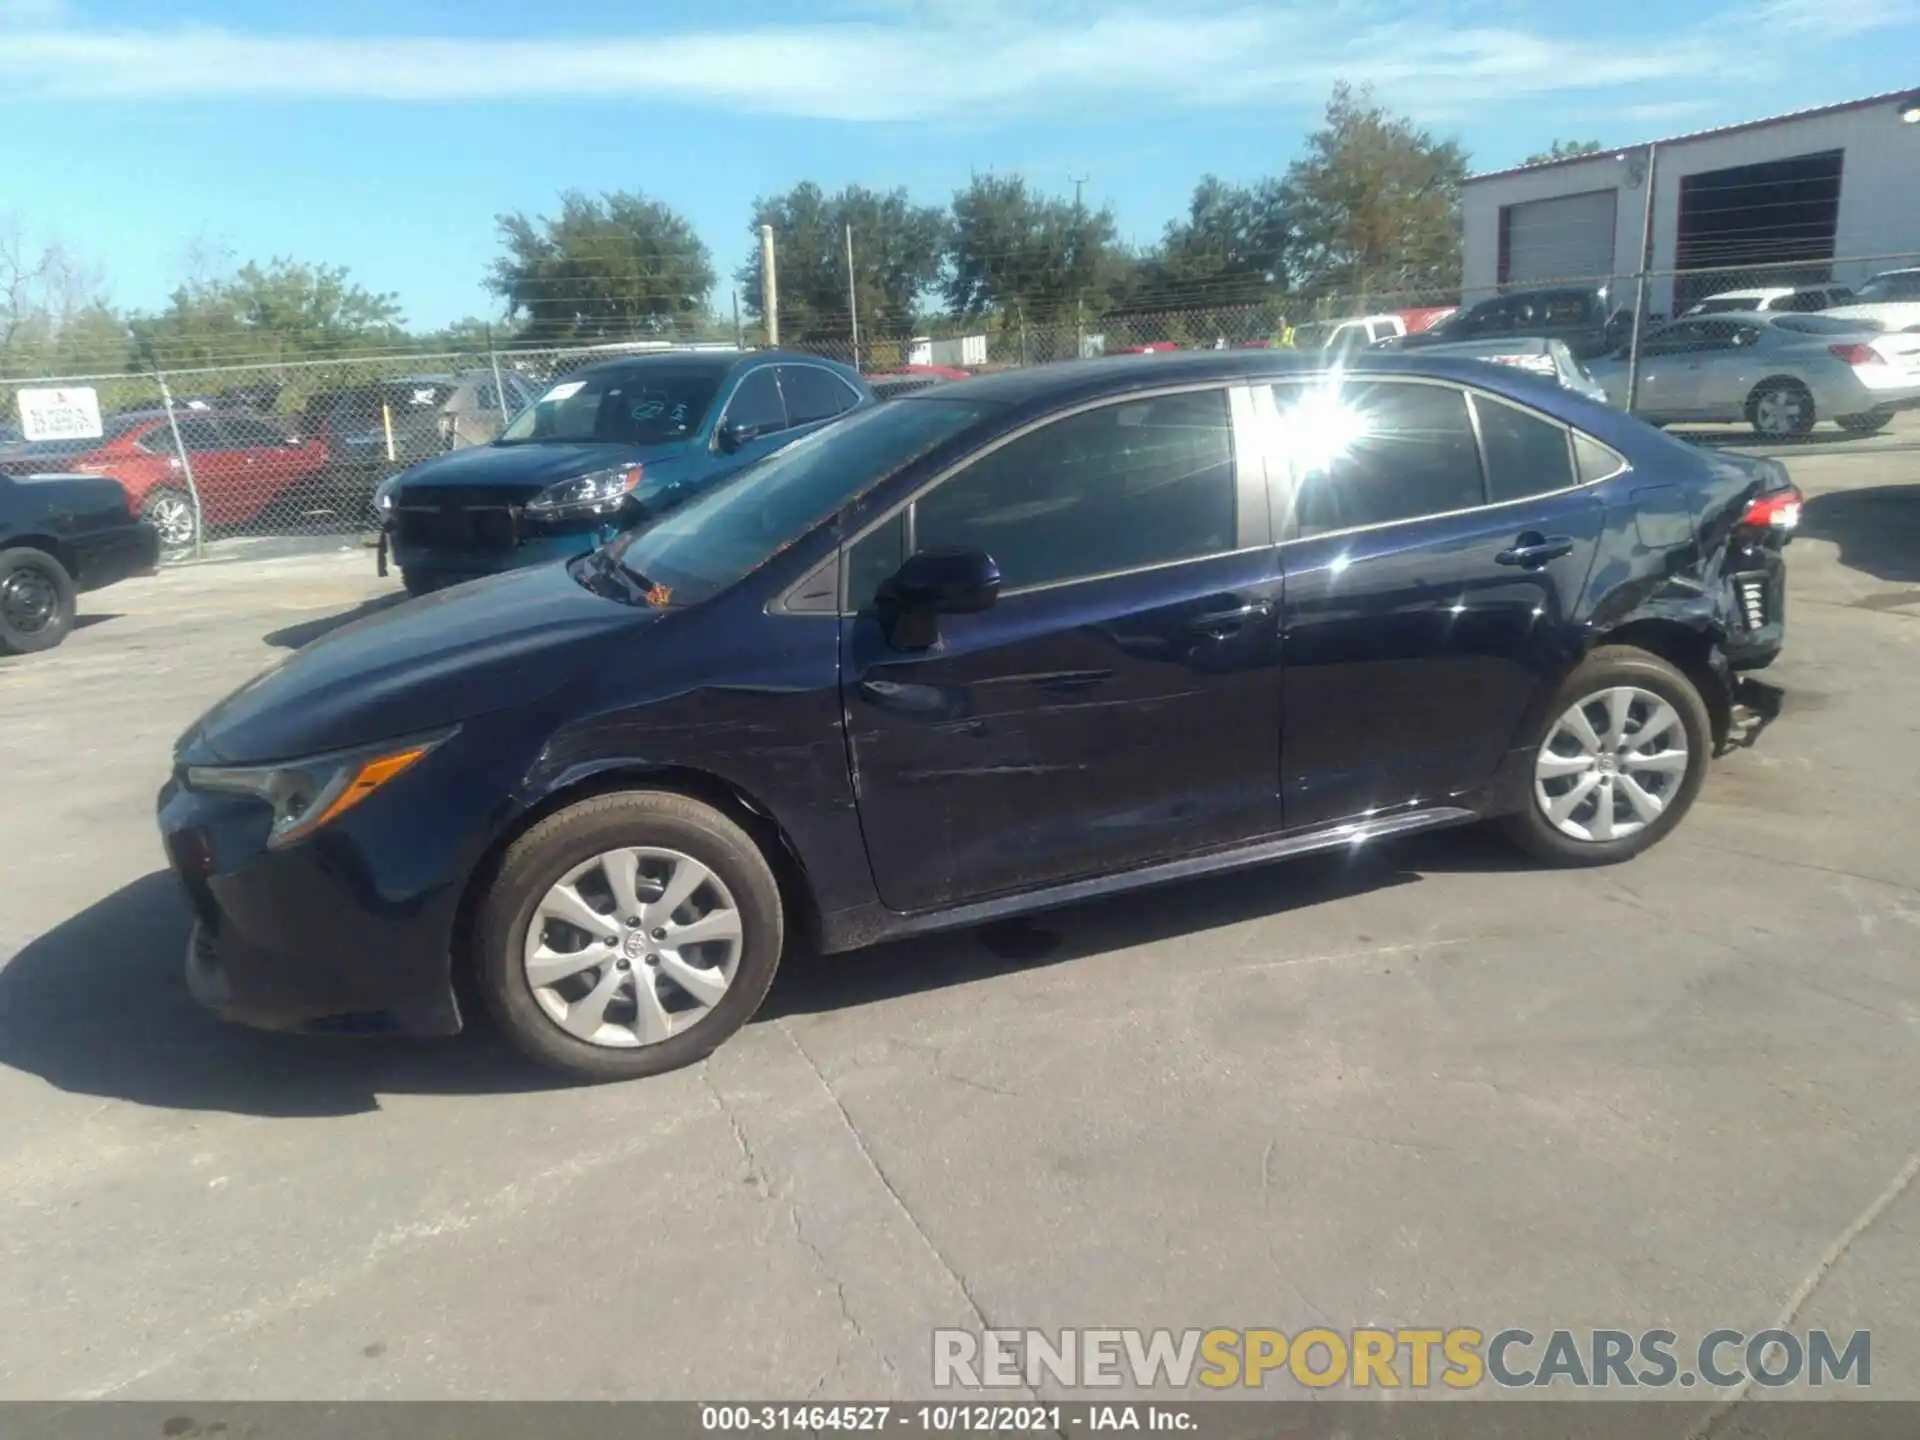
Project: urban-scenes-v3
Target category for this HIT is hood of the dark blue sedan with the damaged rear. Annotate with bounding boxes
[177,564,660,764]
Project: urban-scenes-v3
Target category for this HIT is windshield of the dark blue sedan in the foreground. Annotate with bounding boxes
[607,396,987,605]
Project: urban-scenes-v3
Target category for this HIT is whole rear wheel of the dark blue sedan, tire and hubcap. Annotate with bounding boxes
[1507,645,1713,866]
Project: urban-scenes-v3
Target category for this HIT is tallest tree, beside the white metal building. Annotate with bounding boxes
[1284,84,1467,305]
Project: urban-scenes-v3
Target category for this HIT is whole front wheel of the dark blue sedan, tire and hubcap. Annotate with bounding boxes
[474,791,785,1079]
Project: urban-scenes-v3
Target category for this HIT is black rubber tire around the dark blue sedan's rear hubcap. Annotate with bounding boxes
[1501,645,1713,866]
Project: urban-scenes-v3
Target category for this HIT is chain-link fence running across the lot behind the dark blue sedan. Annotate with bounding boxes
[0,255,1920,559]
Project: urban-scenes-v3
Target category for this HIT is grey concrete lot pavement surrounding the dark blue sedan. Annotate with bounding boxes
[0,422,1920,1400]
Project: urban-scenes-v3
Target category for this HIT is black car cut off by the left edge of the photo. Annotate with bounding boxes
[0,474,159,655]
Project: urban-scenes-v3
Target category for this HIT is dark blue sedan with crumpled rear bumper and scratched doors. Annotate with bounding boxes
[159,351,1799,1077]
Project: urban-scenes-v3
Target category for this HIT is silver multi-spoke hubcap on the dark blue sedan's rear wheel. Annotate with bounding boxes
[1534,685,1688,841]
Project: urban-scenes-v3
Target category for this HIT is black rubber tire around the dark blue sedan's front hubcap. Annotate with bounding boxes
[472,791,785,1081]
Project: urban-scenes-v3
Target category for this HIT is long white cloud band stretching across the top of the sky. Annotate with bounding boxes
[0,0,1910,121]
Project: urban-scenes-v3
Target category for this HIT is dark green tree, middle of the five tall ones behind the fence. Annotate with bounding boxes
[947,175,1131,321]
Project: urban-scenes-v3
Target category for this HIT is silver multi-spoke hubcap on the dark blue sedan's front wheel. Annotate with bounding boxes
[524,847,741,1050]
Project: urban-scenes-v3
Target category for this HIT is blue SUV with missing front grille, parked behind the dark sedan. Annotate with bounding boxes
[374,351,874,595]
